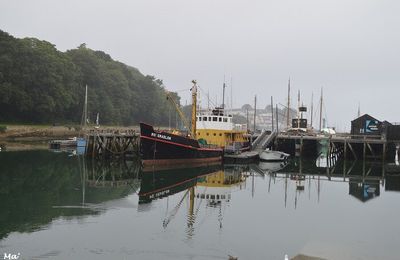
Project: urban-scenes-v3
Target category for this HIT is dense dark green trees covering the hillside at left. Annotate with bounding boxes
[0,31,179,125]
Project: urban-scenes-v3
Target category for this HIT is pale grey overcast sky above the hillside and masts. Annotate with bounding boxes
[0,0,400,131]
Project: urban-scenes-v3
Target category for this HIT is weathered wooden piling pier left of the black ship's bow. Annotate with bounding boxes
[86,131,140,159]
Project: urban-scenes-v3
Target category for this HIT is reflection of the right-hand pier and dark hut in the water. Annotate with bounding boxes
[269,154,400,207]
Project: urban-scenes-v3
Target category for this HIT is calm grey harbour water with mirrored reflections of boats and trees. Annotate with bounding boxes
[0,151,400,259]
